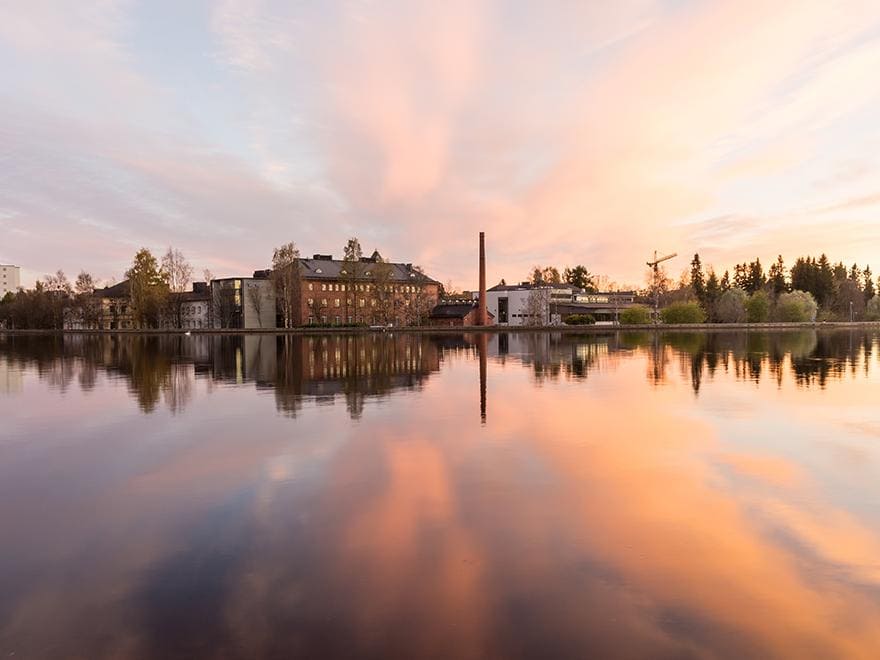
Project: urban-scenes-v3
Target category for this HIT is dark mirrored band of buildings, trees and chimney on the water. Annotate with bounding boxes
[0,330,878,422]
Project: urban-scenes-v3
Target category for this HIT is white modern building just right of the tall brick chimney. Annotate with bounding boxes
[486,282,580,326]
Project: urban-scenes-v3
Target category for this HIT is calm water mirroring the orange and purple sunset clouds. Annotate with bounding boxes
[0,331,880,658]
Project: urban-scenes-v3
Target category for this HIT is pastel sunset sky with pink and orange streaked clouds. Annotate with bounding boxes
[0,0,880,288]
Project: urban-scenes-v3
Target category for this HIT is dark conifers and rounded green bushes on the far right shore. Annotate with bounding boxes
[657,254,880,323]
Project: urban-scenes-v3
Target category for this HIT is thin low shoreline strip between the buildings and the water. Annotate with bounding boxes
[0,321,880,337]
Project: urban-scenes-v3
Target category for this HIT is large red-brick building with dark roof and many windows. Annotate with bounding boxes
[293,252,440,325]
